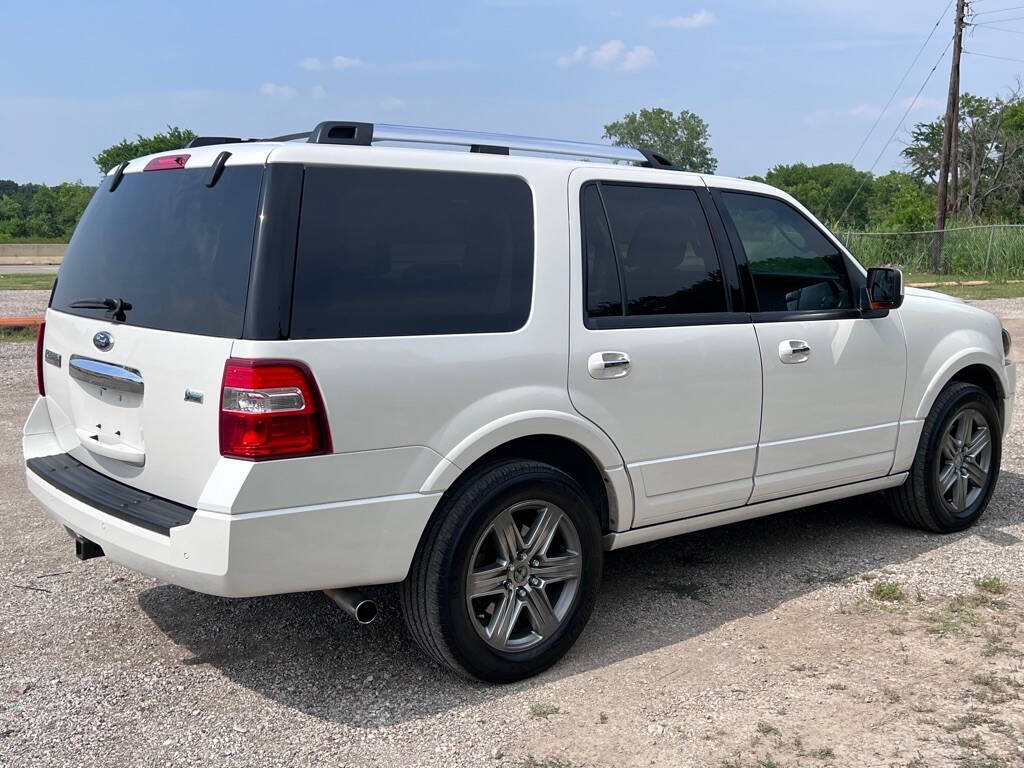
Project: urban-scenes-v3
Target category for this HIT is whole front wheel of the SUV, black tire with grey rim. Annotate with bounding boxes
[888,382,1002,534]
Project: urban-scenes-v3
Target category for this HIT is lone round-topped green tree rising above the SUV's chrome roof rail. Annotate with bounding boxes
[604,108,718,173]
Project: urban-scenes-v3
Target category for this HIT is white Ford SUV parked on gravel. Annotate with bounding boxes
[24,123,1015,681]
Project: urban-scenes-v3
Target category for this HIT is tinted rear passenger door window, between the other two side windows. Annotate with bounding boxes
[583,183,727,316]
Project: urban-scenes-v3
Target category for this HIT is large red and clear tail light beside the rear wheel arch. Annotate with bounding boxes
[220,357,331,461]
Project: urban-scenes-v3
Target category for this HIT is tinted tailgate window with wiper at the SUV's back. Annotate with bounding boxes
[51,166,263,338]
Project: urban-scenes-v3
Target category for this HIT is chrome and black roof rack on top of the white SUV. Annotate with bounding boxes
[188,121,680,170]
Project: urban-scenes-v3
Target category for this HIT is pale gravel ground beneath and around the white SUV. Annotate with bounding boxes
[0,300,1024,768]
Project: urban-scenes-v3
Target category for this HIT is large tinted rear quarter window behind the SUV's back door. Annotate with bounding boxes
[292,168,534,338]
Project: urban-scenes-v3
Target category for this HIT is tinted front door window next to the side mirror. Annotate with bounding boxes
[722,193,853,311]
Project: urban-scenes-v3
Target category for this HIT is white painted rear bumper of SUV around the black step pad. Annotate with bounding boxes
[26,470,439,597]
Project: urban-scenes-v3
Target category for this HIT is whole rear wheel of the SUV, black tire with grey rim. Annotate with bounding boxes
[399,460,603,683]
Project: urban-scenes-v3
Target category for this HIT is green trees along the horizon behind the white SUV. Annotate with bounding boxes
[0,92,1024,242]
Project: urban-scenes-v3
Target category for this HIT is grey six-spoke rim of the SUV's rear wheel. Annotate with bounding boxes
[466,500,583,651]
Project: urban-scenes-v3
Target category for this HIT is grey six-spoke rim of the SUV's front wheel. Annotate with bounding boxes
[936,408,992,514]
